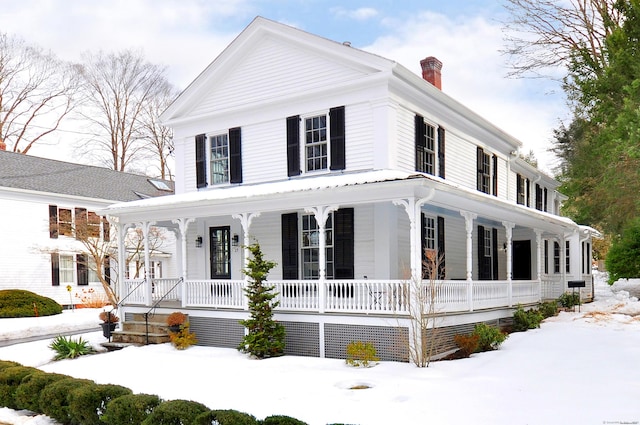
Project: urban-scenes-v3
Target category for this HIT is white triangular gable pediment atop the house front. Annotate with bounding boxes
[162,18,393,124]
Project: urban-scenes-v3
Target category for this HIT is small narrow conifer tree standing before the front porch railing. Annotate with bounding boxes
[238,242,285,359]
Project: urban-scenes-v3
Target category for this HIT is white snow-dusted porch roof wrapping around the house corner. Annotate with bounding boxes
[100,170,578,233]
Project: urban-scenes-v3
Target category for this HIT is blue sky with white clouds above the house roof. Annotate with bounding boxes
[0,0,567,171]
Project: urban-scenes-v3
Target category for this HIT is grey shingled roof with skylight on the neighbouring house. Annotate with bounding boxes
[0,150,174,202]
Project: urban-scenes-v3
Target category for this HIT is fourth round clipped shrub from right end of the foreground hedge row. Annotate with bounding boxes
[102,394,162,425]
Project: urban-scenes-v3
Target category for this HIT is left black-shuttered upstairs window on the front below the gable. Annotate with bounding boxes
[195,127,242,189]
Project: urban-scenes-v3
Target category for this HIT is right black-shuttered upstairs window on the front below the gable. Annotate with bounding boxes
[287,106,346,177]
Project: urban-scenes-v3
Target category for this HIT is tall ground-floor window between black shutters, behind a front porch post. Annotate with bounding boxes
[301,214,334,279]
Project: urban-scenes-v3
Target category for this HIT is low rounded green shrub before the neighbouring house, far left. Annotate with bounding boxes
[0,289,62,318]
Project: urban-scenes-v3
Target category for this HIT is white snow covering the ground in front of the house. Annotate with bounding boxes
[0,276,640,425]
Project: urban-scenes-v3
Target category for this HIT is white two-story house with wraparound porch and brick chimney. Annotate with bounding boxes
[104,17,592,360]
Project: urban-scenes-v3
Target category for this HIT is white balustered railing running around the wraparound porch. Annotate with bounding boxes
[125,279,549,314]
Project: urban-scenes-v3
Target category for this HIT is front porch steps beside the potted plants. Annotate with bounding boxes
[102,313,181,350]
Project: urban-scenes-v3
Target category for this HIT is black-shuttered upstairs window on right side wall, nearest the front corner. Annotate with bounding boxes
[415,114,445,178]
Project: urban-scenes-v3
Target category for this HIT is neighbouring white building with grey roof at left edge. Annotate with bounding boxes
[0,149,175,305]
